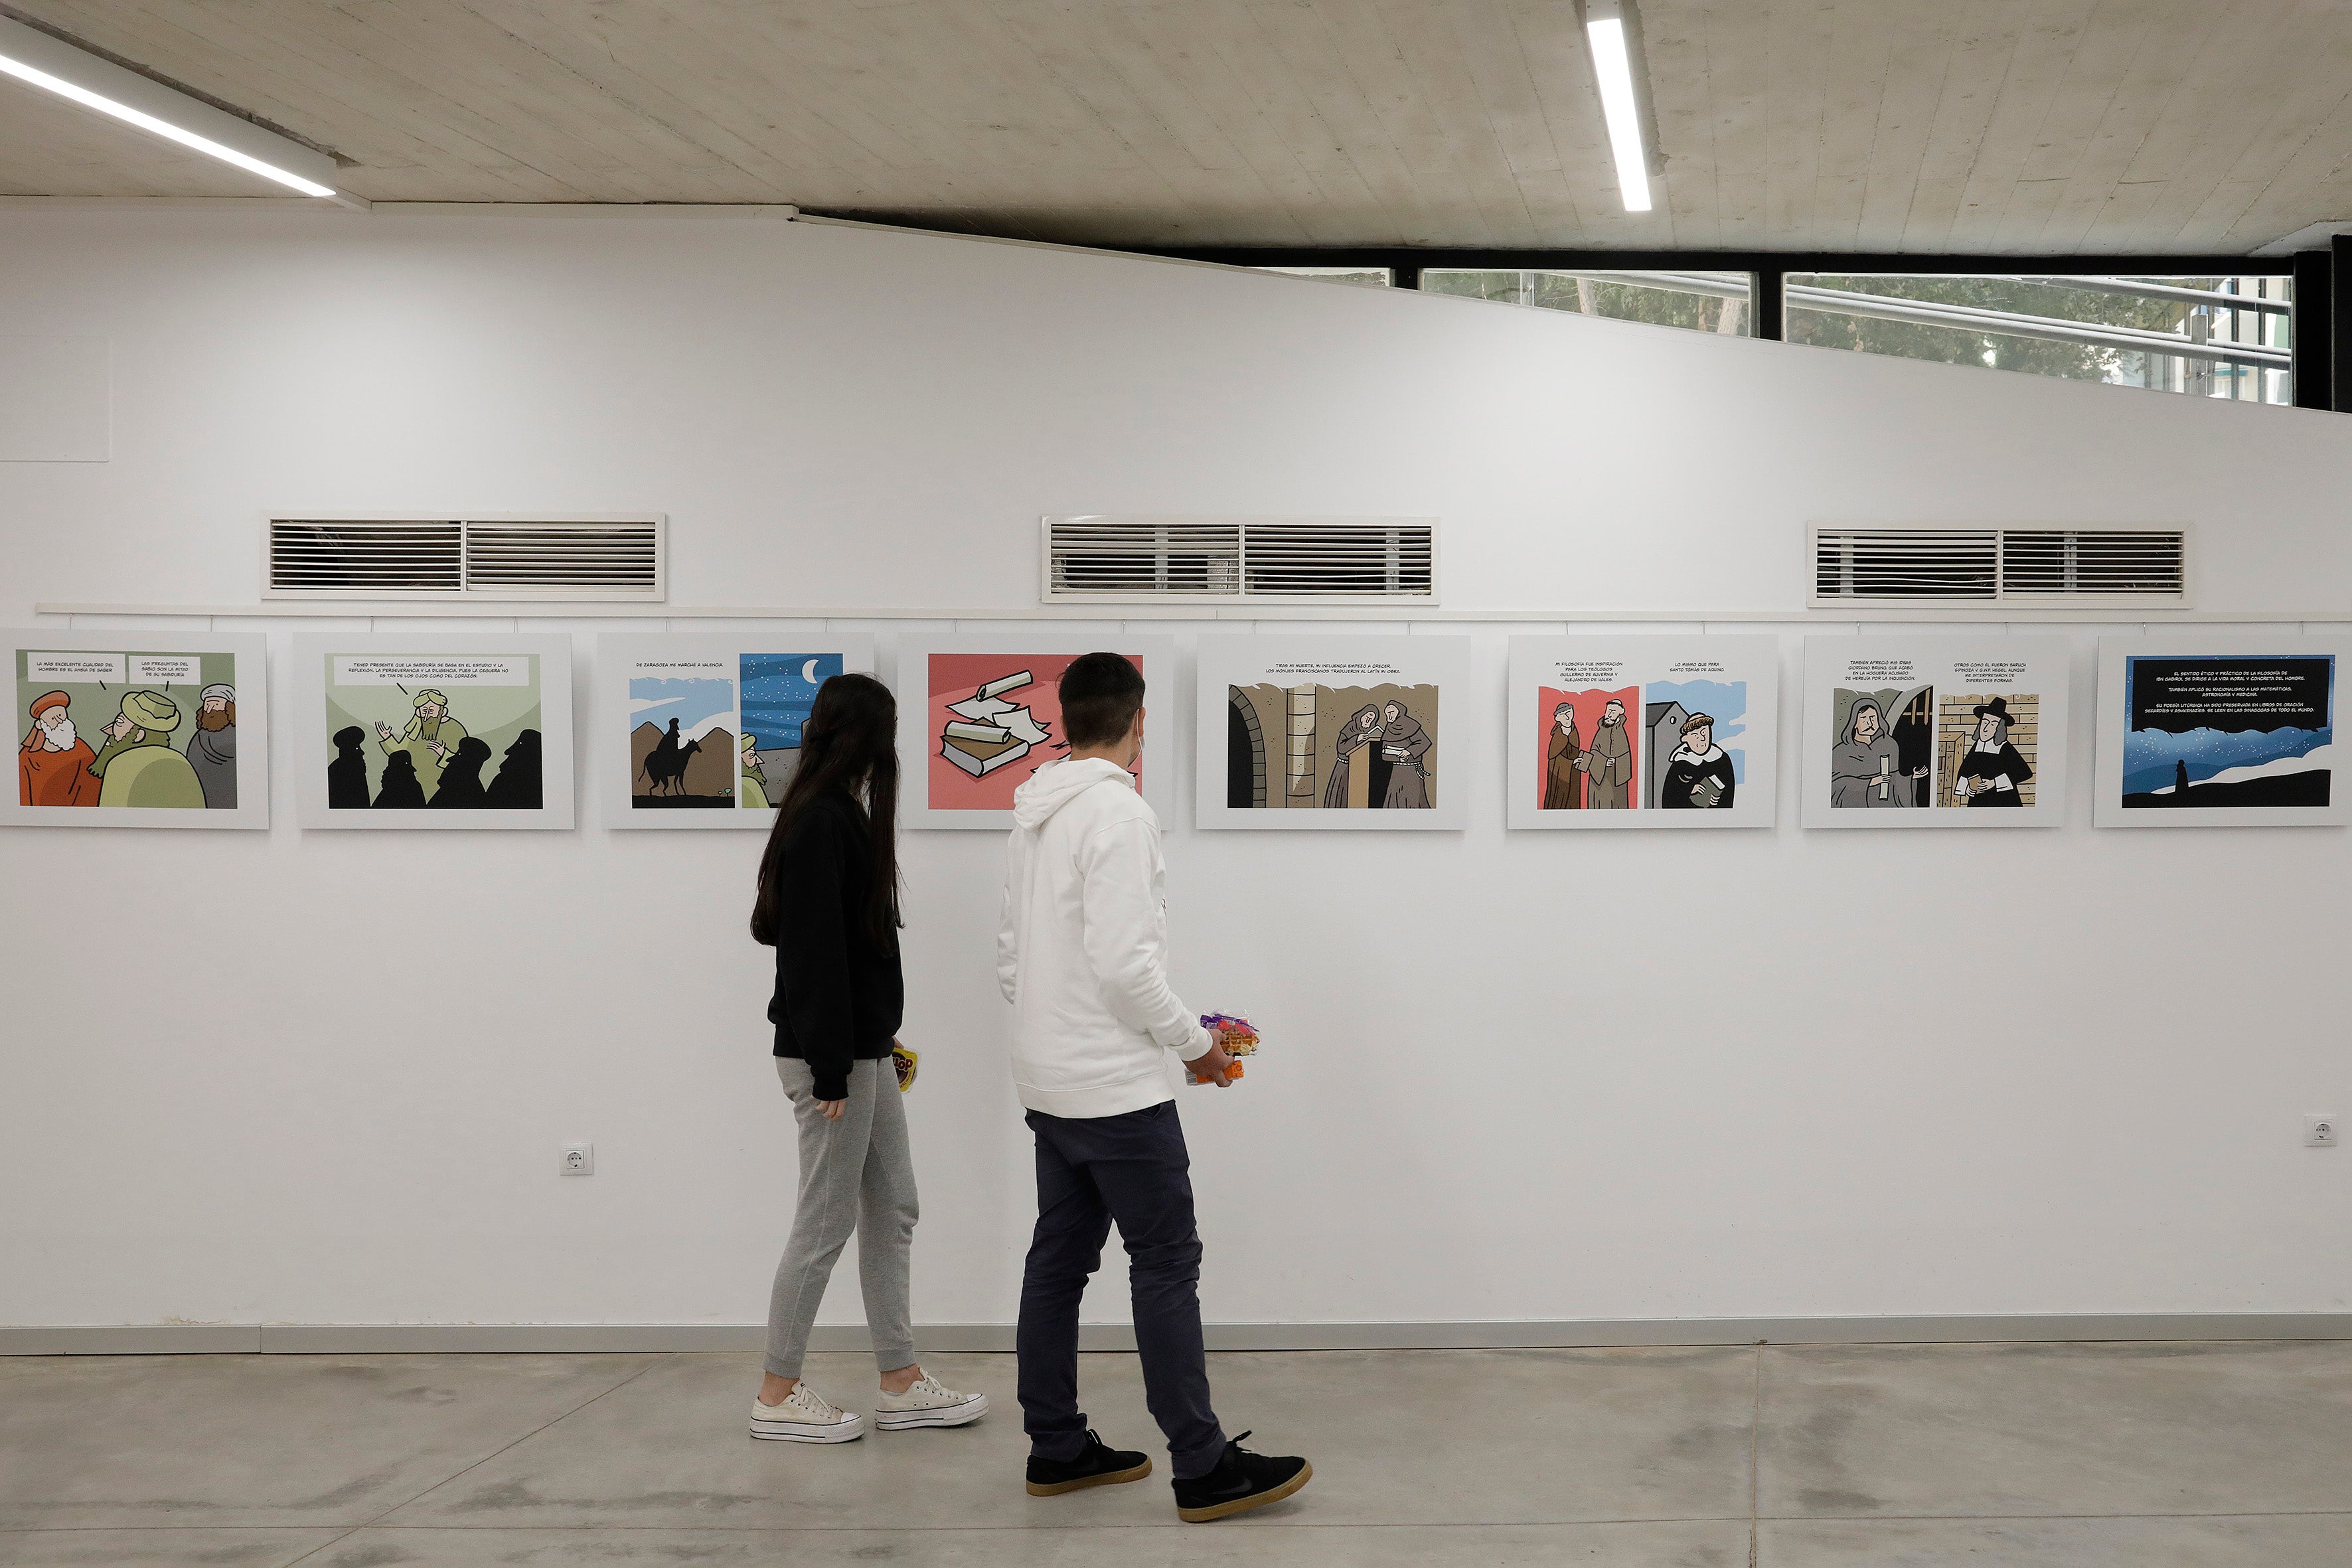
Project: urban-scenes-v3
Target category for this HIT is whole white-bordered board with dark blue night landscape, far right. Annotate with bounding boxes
[2091,630,2352,828]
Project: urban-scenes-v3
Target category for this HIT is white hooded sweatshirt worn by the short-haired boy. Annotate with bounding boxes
[997,757,1209,1117]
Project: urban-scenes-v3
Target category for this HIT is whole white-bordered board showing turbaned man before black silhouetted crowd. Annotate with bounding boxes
[294,633,572,830]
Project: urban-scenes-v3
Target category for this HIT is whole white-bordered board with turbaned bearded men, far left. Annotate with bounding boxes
[0,628,270,828]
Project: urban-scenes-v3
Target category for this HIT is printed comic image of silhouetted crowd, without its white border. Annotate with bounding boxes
[325,653,546,811]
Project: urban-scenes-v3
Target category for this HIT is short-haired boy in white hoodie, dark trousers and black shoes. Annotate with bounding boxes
[997,653,1315,1521]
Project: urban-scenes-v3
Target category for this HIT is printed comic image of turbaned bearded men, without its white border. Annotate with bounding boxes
[17,649,238,811]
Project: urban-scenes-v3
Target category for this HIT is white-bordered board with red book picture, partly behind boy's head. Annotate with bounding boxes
[896,628,1176,830]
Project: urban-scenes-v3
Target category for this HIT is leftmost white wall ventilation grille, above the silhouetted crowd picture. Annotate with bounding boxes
[264,517,663,602]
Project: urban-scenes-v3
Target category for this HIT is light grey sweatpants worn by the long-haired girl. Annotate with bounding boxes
[767,1056,917,1377]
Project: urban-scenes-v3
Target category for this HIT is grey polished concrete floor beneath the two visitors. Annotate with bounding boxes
[0,1345,2352,1568]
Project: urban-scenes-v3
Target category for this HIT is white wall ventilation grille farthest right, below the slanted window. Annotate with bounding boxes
[1811,526,2190,609]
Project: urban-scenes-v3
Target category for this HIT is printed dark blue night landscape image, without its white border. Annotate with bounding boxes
[2122,653,2335,813]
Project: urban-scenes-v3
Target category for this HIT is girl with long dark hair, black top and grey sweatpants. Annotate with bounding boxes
[750,674,988,1443]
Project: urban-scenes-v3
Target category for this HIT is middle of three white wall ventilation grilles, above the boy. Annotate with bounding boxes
[1042,515,1437,604]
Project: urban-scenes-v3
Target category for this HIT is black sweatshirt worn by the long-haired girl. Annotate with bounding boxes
[767,790,905,1100]
